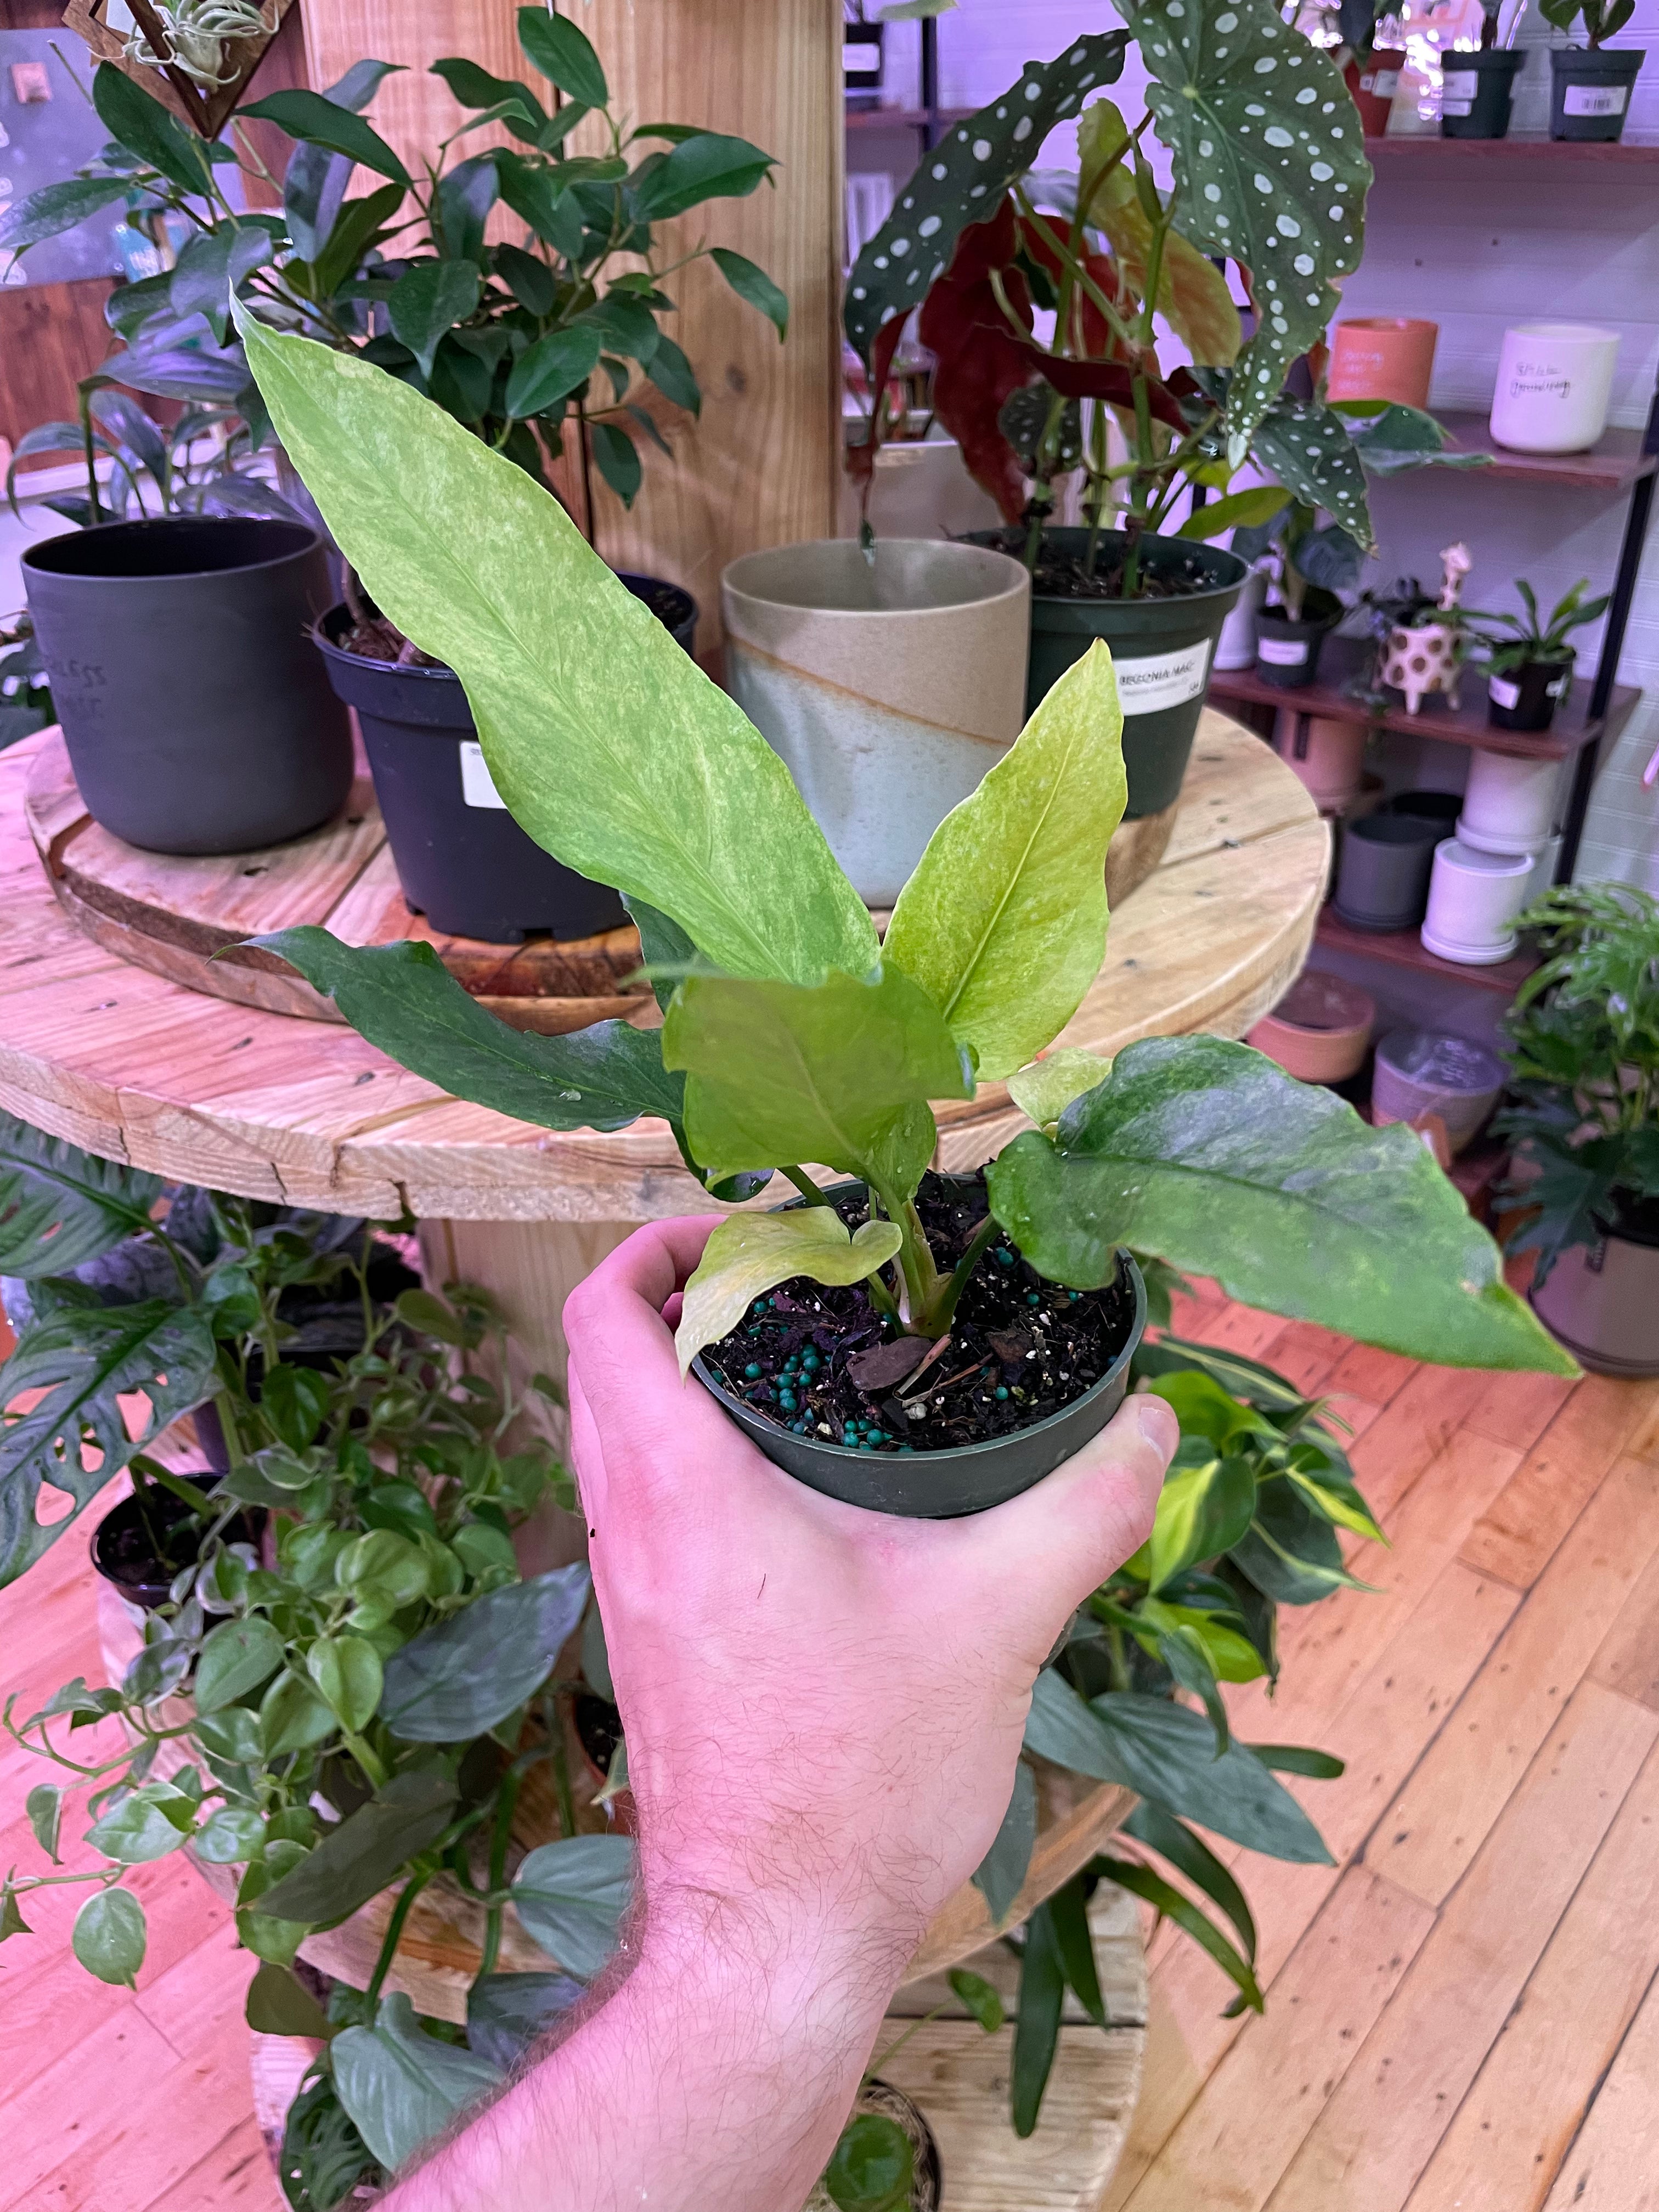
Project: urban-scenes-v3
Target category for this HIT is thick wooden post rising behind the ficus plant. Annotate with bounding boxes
[292,0,843,652]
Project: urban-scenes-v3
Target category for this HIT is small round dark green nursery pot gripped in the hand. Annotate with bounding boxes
[692,1175,1146,1520]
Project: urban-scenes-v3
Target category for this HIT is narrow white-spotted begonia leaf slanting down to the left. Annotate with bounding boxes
[843,31,1128,367]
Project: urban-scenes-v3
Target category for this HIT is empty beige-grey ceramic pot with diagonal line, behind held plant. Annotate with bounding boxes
[721,538,1031,907]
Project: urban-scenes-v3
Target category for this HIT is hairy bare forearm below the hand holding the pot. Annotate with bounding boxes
[383,1898,913,2212]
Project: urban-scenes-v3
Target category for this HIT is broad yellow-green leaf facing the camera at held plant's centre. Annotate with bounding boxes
[662,967,973,1199]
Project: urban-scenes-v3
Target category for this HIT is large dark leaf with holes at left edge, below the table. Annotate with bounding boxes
[0,1299,215,1588]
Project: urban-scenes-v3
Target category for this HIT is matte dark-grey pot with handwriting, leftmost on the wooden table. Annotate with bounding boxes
[22,515,352,854]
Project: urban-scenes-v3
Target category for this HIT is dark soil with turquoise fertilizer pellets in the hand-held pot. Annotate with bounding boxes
[703,1175,1135,1451]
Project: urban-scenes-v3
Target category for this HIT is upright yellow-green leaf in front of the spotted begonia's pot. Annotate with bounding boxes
[898,641,1126,1080]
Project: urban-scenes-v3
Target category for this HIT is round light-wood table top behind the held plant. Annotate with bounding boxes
[0,710,1329,1221]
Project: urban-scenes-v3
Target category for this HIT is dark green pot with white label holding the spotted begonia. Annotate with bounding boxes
[969,529,1250,821]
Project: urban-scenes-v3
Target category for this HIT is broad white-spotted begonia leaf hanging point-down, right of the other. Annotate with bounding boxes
[1121,0,1372,467]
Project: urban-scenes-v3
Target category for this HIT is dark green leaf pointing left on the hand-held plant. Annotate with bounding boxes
[250,927,684,1128]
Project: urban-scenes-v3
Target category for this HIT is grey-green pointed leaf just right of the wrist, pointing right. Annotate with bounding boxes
[1026,1668,1331,1867]
